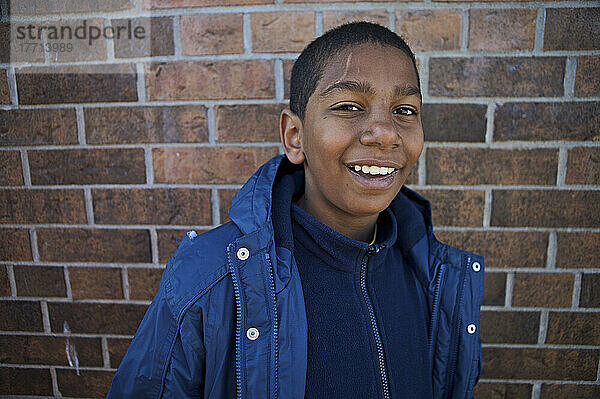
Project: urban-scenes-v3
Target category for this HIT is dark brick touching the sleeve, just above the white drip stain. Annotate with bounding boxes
[48,302,147,335]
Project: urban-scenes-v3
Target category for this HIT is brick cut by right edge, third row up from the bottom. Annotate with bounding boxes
[546,312,600,346]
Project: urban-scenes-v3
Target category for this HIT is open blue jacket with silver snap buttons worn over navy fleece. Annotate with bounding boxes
[108,155,483,399]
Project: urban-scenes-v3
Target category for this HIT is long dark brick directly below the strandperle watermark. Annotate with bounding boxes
[16,64,138,104]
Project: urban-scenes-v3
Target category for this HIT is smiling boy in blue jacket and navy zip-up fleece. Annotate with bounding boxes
[108,22,483,398]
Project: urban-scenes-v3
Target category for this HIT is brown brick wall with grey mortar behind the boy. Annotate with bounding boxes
[0,0,600,398]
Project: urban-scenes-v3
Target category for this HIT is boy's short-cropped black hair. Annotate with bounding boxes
[290,21,421,120]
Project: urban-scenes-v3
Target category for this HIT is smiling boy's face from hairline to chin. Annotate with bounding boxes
[282,43,423,227]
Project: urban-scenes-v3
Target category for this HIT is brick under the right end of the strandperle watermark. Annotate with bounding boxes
[111,17,175,58]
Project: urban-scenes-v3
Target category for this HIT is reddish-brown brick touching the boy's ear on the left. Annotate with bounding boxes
[215,104,283,143]
